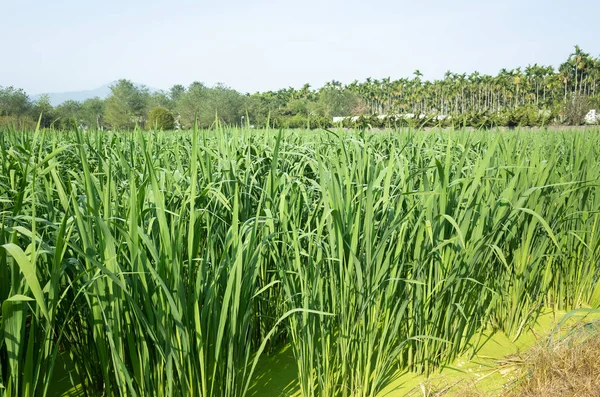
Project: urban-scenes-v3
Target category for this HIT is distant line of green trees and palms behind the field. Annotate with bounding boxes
[0,46,600,130]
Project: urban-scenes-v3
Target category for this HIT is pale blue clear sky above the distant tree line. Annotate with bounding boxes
[0,0,600,94]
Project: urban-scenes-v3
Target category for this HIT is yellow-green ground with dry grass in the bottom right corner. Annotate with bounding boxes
[388,312,600,397]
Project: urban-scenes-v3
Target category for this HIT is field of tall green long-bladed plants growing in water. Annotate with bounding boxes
[0,124,600,397]
